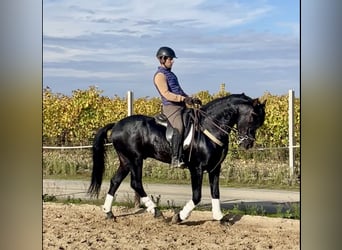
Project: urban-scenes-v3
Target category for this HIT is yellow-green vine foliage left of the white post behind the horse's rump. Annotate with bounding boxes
[43,86,127,145]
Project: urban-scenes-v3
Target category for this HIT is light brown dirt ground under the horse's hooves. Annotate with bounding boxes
[43,202,300,250]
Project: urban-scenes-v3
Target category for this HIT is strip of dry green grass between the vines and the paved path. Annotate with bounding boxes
[43,149,300,190]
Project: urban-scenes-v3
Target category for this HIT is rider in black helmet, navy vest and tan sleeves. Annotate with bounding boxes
[153,47,202,167]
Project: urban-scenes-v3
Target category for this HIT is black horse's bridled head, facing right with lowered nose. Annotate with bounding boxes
[237,98,266,149]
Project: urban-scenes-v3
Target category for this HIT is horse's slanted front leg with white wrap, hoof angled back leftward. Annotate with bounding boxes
[172,168,203,223]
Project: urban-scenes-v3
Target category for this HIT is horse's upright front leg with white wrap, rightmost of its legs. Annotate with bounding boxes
[209,165,223,220]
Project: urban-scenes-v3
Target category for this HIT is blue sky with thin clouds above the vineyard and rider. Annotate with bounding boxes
[43,0,300,97]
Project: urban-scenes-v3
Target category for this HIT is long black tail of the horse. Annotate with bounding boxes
[88,123,115,197]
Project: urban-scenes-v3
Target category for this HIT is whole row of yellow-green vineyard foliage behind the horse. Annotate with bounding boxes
[43,84,300,149]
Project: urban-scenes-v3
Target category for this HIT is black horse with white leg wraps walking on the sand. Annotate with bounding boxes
[88,93,266,222]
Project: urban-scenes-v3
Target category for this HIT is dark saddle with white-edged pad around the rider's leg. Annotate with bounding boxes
[154,108,198,149]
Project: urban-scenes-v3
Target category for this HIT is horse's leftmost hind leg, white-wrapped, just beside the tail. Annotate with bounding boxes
[102,157,130,218]
